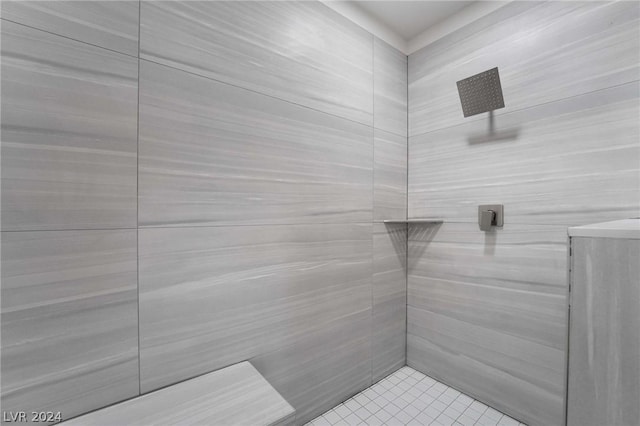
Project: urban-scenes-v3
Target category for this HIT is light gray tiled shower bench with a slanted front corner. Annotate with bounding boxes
[62,362,295,426]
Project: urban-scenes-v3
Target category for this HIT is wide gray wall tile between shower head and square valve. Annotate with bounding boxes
[409,82,640,225]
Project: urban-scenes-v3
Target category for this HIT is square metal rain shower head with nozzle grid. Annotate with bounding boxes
[456,67,504,117]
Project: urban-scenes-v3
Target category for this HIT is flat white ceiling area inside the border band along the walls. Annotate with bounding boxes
[353,0,474,42]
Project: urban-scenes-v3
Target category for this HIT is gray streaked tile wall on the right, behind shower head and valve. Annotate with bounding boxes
[407,2,640,425]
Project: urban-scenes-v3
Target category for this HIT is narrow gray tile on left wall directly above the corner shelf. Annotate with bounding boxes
[373,129,407,220]
